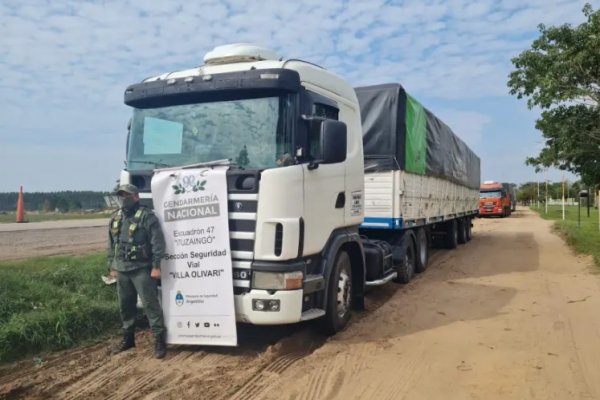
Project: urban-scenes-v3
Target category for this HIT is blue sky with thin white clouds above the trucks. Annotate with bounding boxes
[0,0,598,192]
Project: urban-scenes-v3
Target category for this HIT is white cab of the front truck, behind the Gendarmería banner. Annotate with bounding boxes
[120,44,365,332]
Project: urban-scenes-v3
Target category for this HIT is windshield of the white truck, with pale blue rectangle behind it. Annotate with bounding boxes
[127,94,293,171]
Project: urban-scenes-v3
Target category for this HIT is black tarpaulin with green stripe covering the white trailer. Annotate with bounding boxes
[355,83,480,189]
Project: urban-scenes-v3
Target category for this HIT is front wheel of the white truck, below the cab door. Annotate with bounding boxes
[322,250,352,335]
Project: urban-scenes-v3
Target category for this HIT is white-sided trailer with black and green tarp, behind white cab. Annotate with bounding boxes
[356,83,480,286]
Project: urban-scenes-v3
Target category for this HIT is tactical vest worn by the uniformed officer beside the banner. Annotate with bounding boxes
[110,207,150,262]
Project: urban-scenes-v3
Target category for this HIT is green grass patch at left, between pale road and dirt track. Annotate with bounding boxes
[0,254,120,363]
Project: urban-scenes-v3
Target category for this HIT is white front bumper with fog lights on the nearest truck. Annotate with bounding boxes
[234,289,303,325]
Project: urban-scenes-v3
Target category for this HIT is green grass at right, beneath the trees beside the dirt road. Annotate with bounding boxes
[531,205,600,267]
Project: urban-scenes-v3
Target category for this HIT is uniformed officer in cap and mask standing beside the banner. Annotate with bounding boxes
[108,185,167,358]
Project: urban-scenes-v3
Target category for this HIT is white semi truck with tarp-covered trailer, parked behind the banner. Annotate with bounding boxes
[121,44,479,333]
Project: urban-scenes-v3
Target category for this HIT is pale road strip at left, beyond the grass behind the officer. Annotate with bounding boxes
[0,219,108,261]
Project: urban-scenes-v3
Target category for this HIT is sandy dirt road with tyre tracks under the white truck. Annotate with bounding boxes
[0,210,600,400]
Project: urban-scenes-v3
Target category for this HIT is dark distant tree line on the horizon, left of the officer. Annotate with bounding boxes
[0,191,110,212]
